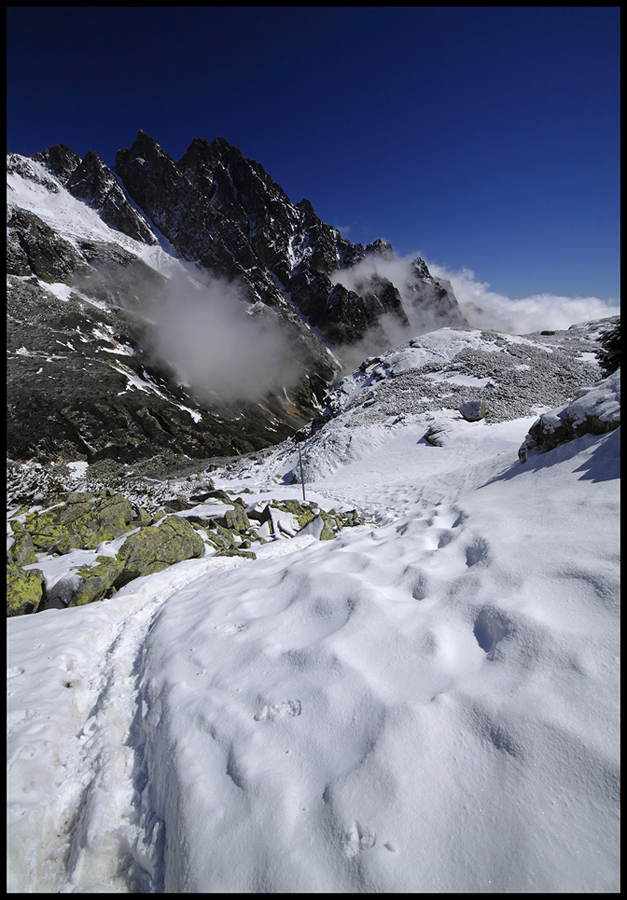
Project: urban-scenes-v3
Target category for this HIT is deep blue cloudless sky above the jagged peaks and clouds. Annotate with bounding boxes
[7,7,620,300]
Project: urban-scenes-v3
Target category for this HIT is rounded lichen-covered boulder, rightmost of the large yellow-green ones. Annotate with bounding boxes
[115,516,205,587]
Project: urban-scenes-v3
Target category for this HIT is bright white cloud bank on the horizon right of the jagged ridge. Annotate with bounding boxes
[428,263,620,334]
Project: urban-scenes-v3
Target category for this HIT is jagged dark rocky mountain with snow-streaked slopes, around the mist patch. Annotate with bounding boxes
[7,131,465,461]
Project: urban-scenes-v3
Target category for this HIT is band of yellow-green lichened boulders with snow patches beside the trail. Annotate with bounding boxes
[7,488,364,616]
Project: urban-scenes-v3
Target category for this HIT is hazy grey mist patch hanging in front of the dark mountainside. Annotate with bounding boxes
[75,261,303,404]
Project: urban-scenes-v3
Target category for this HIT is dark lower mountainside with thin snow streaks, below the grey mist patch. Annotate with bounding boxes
[7,278,310,462]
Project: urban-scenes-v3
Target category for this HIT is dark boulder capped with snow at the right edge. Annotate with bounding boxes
[518,368,620,462]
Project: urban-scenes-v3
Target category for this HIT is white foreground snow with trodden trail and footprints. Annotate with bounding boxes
[7,396,620,893]
